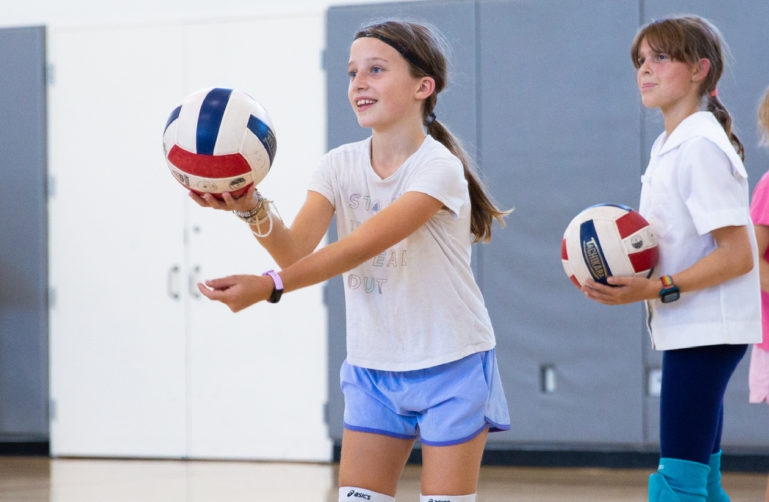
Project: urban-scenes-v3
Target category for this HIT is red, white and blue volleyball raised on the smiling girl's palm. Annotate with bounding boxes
[163,87,277,198]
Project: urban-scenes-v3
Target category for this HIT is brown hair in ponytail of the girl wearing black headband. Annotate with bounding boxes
[355,20,510,242]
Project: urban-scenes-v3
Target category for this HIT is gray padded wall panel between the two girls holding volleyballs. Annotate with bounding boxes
[479,0,644,445]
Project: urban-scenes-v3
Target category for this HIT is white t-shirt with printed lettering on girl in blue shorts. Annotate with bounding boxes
[309,136,495,371]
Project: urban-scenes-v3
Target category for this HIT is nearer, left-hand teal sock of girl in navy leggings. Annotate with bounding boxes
[649,458,710,502]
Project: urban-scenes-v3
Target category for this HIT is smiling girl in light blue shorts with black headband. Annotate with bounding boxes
[190,21,510,502]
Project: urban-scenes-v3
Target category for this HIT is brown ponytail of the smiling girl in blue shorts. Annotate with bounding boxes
[425,117,512,243]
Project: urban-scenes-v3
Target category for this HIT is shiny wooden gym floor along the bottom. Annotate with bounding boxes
[0,457,766,502]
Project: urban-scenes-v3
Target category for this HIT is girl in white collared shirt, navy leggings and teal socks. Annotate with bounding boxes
[583,16,761,502]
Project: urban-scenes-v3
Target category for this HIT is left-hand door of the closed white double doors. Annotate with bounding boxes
[49,24,186,457]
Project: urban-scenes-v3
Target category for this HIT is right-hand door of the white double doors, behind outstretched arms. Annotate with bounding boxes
[186,15,331,461]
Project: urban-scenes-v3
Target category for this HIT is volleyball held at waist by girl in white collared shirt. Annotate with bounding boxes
[561,204,659,287]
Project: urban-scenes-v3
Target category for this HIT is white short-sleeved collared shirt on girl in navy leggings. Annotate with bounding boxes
[639,112,761,350]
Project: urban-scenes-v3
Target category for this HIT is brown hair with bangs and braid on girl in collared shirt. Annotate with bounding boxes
[630,16,745,160]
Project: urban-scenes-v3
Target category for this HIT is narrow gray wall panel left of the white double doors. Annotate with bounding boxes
[0,27,48,440]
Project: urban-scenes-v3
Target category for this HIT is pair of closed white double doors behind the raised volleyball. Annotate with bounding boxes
[49,14,331,461]
